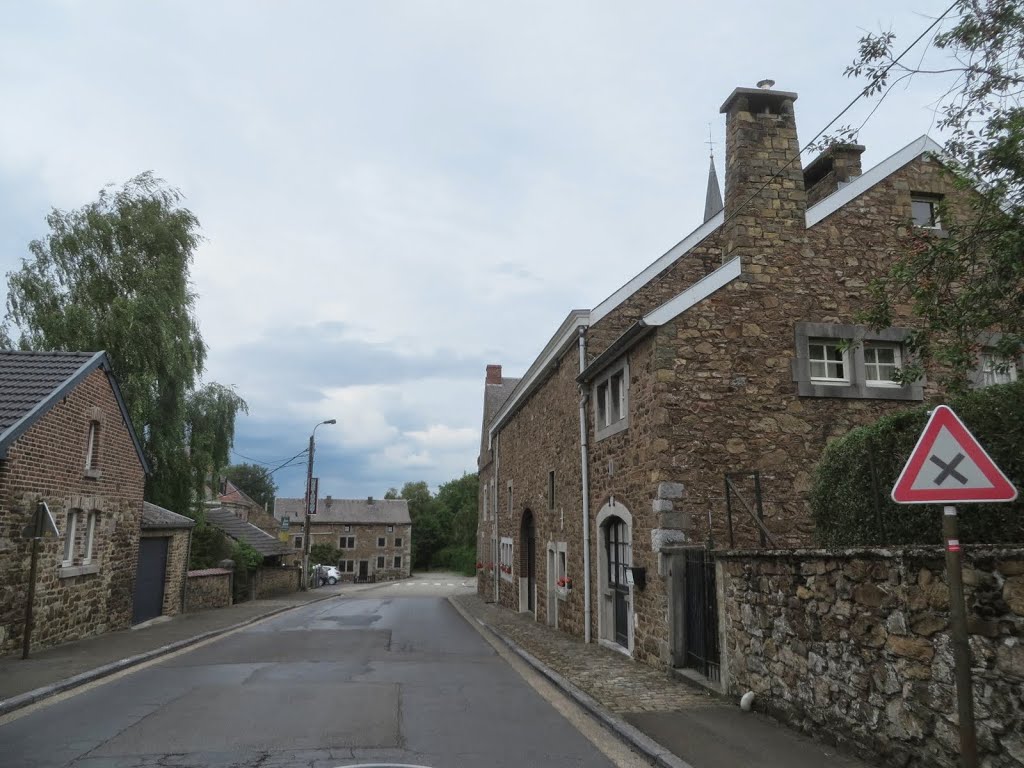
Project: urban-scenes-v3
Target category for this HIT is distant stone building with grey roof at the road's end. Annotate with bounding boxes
[273,496,413,582]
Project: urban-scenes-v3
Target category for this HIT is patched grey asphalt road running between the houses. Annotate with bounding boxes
[0,577,640,768]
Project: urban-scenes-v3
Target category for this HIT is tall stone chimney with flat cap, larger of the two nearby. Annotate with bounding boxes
[721,80,807,270]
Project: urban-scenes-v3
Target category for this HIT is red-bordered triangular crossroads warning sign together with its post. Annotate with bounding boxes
[892,406,1017,768]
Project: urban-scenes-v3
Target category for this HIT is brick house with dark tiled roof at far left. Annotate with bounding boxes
[0,351,147,653]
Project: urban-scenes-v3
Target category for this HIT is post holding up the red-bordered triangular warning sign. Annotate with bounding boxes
[942,507,978,768]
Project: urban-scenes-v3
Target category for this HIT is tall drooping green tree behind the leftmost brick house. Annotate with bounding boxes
[4,173,246,512]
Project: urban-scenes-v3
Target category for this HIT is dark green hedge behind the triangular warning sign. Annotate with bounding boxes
[810,382,1024,547]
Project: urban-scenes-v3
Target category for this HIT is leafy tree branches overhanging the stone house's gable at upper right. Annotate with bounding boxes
[840,0,1024,391]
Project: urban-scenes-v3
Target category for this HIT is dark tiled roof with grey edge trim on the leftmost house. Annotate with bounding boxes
[0,349,150,474]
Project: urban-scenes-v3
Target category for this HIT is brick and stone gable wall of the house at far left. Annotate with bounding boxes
[0,369,144,654]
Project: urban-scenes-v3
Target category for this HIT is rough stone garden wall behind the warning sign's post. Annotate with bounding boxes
[719,549,1024,768]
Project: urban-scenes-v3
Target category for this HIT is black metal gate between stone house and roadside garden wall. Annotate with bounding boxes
[683,548,722,681]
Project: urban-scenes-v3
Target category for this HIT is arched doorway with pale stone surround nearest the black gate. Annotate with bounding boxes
[597,499,633,652]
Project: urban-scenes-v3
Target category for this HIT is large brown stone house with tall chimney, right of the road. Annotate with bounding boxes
[478,81,1016,664]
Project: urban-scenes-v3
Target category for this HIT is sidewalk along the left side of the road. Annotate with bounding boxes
[0,587,340,715]
